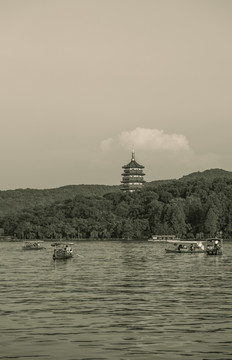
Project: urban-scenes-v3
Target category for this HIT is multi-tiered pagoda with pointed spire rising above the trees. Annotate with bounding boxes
[121,150,145,192]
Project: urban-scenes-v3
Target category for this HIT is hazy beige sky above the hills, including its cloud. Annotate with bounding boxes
[0,0,232,190]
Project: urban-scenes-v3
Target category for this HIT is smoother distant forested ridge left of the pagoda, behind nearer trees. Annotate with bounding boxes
[0,185,119,216]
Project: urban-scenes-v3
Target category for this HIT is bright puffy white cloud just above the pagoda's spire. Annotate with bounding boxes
[119,127,190,151]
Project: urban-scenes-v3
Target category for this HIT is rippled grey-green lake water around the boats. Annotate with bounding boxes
[0,241,232,360]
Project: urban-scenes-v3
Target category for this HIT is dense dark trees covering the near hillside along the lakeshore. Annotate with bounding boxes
[0,178,232,239]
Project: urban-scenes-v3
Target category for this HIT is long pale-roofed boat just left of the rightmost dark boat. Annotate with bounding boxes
[165,240,205,254]
